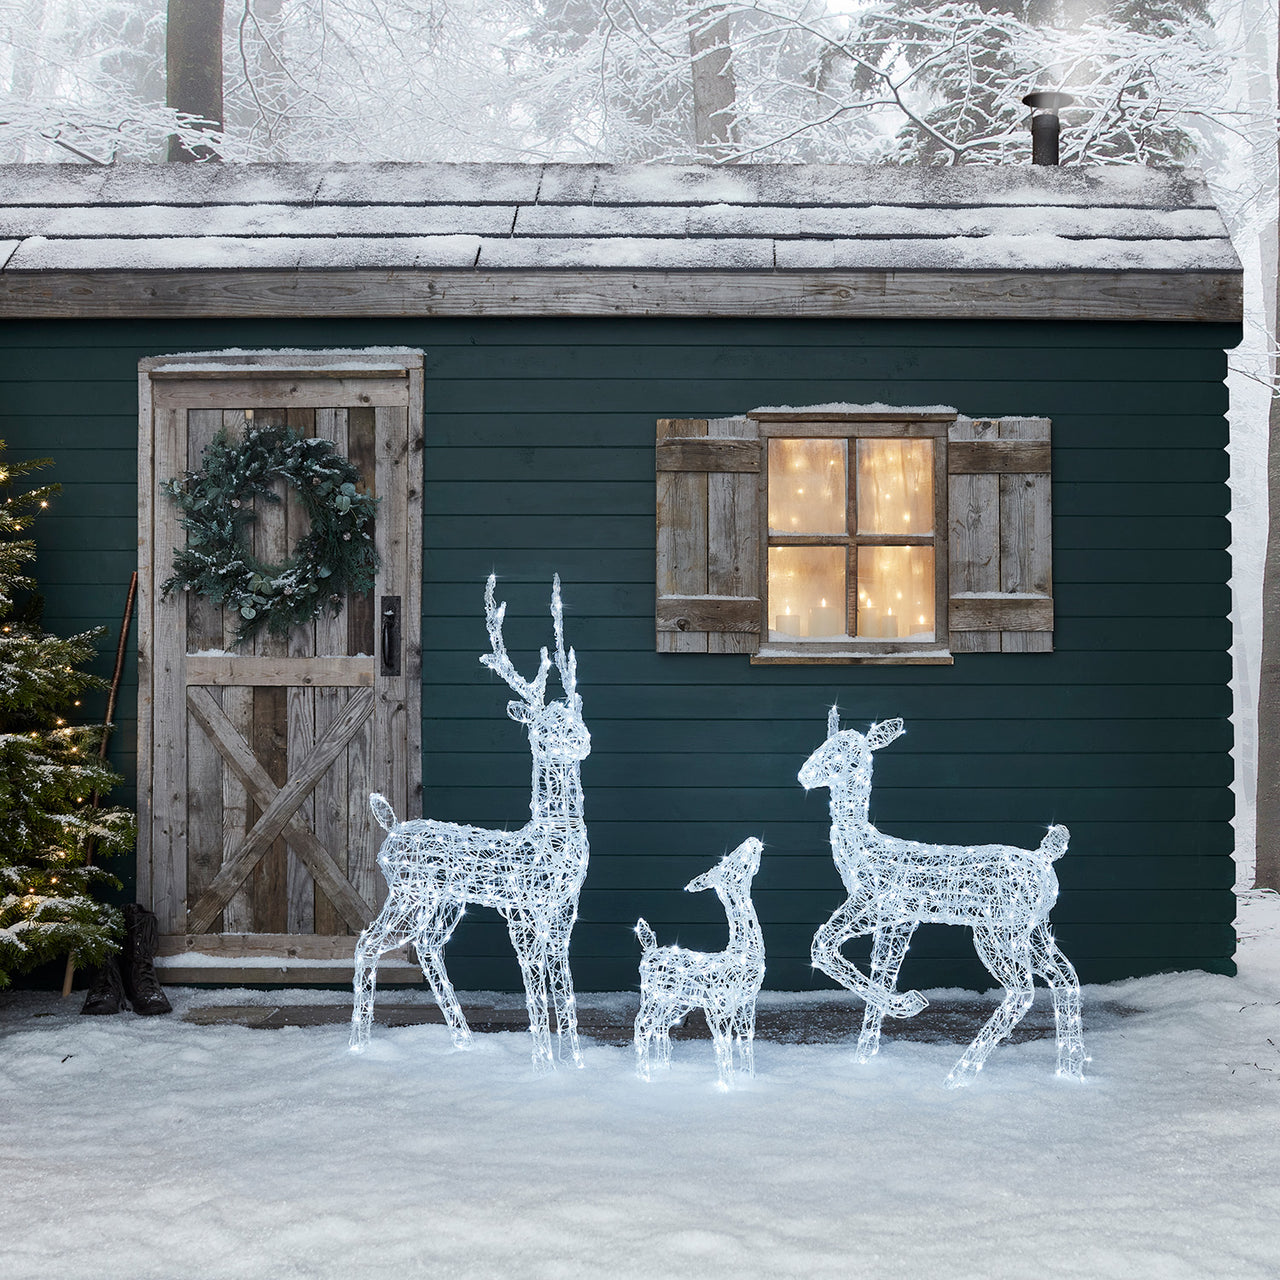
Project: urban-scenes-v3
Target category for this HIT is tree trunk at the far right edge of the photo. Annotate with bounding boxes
[1253,7,1280,890]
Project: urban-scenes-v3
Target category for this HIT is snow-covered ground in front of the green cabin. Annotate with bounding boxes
[0,895,1280,1280]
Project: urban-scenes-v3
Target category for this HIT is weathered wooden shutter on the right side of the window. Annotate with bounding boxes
[947,417,1053,653]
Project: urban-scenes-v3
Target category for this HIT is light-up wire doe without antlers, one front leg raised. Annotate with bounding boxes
[800,707,1085,1088]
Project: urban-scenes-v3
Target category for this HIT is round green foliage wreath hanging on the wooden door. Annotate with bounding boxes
[163,420,379,644]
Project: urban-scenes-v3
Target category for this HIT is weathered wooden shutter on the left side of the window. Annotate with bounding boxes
[657,417,763,653]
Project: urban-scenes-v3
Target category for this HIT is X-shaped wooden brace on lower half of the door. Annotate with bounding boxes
[187,685,374,933]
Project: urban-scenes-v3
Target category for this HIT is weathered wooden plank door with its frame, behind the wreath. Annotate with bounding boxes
[138,352,422,977]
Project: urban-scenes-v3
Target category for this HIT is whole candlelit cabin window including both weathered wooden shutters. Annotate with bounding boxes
[657,406,1053,663]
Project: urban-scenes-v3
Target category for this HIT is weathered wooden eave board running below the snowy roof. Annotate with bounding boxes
[0,268,1243,324]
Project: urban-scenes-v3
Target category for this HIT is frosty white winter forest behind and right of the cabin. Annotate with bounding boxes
[0,0,1280,882]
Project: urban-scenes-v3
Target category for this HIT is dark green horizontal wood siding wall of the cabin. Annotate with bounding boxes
[0,319,1239,989]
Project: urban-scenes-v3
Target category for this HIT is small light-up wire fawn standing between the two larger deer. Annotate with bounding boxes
[635,837,764,1089]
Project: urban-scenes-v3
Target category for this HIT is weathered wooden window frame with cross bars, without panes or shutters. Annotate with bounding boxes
[748,410,956,664]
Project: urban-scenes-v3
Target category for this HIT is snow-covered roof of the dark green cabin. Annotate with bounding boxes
[0,164,1240,319]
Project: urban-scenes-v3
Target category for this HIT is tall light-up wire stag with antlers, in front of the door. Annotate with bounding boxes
[351,573,591,1070]
